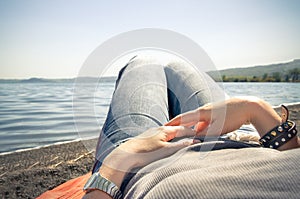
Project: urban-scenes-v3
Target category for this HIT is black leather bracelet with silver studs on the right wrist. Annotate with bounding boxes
[259,120,297,149]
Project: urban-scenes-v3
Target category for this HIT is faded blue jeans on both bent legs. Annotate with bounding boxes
[93,56,226,172]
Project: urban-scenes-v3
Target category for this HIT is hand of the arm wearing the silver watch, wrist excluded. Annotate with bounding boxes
[118,126,196,167]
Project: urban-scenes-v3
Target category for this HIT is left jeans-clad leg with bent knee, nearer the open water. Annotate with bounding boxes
[93,57,169,172]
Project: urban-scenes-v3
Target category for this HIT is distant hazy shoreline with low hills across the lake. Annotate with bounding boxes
[0,59,300,83]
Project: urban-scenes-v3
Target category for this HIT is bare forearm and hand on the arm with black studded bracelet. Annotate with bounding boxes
[166,97,300,150]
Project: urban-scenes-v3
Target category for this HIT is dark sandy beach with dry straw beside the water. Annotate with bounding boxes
[0,103,300,198]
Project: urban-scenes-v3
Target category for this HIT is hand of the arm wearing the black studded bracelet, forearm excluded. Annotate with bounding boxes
[165,98,252,136]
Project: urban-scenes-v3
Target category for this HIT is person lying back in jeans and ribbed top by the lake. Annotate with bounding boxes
[84,54,300,198]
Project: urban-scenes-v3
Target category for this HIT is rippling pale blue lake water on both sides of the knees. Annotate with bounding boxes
[0,81,300,153]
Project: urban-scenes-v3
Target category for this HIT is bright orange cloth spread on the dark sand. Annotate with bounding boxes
[37,173,91,199]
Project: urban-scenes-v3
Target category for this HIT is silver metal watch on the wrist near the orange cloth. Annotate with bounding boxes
[83,172,122,199]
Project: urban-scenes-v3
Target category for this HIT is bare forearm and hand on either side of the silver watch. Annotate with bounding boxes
[84,126,196,199]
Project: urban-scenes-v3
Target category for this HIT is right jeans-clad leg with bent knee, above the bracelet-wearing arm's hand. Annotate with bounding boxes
[165,59,228,118]
